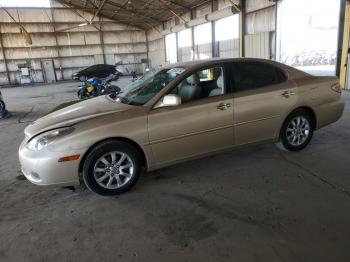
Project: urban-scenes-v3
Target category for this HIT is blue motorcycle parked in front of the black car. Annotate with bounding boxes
[78,74,120,99]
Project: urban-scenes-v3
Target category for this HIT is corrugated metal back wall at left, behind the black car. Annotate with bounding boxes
[0,1,148,85]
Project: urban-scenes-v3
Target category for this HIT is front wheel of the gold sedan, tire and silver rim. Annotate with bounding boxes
[83,141,143,196]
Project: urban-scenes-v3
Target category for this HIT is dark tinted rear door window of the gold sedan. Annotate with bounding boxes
[234,62,286,92]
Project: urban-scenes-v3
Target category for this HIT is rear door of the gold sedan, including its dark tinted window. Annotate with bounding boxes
[231,61,297,145]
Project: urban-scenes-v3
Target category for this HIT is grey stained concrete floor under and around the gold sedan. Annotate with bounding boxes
[0,79,350,262]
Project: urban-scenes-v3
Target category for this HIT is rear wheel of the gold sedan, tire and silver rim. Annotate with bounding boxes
[280,109,315,151]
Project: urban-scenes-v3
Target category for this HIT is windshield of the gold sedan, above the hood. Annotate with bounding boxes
[117,68,185,105]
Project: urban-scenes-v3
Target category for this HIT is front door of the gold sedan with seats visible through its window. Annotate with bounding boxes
[148,66,233,165]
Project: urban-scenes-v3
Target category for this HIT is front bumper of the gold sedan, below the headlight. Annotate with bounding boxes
[18,140,82,186]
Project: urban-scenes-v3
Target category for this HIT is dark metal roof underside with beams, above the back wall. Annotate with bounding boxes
[58,0,210,29]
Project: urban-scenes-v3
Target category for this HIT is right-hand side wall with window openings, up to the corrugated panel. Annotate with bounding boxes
[147,0,276,67]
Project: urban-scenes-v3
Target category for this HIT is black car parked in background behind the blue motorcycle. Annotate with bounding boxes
[72,64,117,82]
